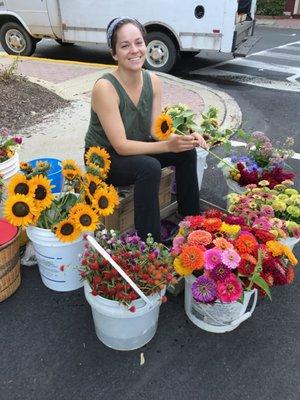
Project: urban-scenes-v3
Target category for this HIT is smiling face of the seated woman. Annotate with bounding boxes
[113,23,146,71]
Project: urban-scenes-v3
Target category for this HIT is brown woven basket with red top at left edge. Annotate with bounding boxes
[0,219,21,302]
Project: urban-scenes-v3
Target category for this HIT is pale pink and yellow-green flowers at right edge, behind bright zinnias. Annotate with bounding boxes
[228,181,300,239]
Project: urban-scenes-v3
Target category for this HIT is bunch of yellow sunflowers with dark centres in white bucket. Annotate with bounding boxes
[4,147,119,242]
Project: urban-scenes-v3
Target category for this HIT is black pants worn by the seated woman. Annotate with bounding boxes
[86,150,200,242]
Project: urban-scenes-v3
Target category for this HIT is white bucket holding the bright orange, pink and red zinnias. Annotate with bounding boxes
[184,276,257,333]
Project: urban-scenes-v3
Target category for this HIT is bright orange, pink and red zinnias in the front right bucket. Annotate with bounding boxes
[172,210,297,303]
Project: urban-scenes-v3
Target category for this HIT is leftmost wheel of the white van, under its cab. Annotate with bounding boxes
[0,22,37,56]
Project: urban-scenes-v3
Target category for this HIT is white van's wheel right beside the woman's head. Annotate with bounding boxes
[145,32,178,72]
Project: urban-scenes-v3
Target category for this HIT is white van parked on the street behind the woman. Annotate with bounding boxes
[0,0,256,72]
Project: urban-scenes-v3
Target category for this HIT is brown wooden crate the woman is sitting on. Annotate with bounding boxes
[103,168,174,232]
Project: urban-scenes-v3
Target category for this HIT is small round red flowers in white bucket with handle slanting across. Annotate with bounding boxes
[81,229,176,312]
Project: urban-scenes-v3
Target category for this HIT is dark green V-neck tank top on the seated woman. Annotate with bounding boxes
[85,70,153,150]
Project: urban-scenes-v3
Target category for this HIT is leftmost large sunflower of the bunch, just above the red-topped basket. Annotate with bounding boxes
[4,194,38,227]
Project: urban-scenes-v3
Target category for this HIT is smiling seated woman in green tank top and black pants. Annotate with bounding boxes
[85,17,206,242]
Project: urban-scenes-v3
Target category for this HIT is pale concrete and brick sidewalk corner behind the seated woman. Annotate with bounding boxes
[0,53,242,165]
